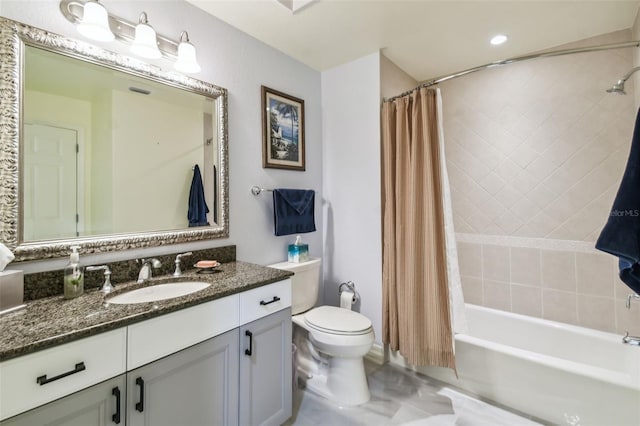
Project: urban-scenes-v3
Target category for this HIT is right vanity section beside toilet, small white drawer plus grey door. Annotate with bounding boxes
[239,280,292,426]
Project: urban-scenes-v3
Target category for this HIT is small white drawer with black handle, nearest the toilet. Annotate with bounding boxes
[240,279,291,325]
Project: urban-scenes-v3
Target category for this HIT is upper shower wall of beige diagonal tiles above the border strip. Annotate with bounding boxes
[442,31,635,241]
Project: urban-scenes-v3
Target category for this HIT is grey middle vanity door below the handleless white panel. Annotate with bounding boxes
[127,329,239,426]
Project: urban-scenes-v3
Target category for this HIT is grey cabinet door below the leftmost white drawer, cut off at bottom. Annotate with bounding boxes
[0,374,126,426]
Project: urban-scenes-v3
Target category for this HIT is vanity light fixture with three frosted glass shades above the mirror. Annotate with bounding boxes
[60,0,201,73]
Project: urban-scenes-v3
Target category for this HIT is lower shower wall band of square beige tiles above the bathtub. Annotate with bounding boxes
[458,238,640,335]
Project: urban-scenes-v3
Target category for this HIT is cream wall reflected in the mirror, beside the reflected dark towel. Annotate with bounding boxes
[112,91,204,232]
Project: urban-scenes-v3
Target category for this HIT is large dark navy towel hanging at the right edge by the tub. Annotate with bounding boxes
[596,111,640,294]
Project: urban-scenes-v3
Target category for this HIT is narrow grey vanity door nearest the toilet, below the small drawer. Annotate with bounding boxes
[240,309,292,426]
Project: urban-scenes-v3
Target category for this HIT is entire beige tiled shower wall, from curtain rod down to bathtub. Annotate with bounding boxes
[441,30,640,333]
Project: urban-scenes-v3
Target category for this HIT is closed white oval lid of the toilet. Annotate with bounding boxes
[304,306,371,334]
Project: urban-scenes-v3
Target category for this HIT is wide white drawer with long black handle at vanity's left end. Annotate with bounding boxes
[0,328,127,420]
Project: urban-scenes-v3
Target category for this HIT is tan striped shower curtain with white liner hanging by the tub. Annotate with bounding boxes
[382,88,466,369]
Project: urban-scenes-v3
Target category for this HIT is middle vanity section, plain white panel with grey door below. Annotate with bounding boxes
[127,294,239,426]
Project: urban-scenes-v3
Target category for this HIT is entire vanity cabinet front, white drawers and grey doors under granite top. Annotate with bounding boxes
[0,279,292,426]
